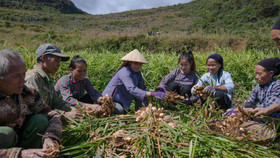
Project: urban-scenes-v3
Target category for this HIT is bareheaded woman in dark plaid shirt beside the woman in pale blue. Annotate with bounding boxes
[157,51,198,105]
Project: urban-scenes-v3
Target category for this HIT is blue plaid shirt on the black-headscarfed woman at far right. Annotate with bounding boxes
[244,79,280,117]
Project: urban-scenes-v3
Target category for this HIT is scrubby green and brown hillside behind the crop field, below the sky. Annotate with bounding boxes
[0,0,280,52]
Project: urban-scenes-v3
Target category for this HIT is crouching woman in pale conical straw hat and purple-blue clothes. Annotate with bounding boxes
[102,49,165,114]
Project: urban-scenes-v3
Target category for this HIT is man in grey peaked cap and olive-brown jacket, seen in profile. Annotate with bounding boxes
[25,44,76,118]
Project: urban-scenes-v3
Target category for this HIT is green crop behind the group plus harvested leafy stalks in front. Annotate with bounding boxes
[10,47,280,157]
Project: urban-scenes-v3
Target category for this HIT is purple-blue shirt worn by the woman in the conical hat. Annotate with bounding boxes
[102,66,147,110]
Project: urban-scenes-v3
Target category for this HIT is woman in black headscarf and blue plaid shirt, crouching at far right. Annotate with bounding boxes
[243,57,280,117]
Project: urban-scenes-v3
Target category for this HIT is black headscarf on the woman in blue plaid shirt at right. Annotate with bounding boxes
[257,57,280,76]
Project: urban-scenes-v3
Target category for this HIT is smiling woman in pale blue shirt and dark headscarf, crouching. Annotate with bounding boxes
[192,53,234,110]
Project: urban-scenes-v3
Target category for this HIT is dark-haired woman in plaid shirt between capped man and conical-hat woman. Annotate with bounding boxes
[55,55,102,114]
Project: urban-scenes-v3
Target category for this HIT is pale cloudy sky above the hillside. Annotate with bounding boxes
[72,0,191,14]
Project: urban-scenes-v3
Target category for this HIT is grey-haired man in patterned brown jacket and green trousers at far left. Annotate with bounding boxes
[0,49,62,158]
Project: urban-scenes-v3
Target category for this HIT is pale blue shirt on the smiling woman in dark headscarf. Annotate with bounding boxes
[192,71,234,102]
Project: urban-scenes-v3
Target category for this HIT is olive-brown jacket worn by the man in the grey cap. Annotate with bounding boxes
[25,65,73,112]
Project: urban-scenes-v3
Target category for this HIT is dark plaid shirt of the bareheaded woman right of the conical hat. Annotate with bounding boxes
[159,68,198,87]
